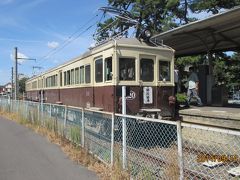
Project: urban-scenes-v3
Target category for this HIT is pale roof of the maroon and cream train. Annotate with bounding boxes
[27,38,174,82]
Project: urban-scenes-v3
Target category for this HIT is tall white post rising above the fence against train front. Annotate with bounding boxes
[122,86,127,169]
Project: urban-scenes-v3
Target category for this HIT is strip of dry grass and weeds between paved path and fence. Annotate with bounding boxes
[0,106,130,180]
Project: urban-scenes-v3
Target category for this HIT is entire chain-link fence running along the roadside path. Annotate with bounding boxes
[0,99,240,179]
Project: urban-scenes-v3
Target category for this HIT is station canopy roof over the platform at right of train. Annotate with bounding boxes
[152,7,240,57]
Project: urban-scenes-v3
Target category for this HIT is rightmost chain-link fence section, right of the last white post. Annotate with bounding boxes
[182,123,240,179]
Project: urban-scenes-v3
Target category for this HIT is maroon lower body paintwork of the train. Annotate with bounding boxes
[27,86,174,114]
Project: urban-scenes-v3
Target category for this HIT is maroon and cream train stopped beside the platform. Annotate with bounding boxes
[26,38,174,116]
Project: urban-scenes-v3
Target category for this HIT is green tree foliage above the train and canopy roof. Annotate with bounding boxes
[94,0,240,41]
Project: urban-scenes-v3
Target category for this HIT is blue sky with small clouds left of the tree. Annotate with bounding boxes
[0,0,107,85]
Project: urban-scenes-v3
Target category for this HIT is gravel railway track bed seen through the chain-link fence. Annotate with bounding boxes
[64,117,240,180]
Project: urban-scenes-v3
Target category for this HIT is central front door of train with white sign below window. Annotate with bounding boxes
[139,56,156,109]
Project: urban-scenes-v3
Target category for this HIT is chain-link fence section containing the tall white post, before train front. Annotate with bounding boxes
[114,114,179,179]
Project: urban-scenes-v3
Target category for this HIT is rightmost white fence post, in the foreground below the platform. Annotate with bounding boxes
[177,120,184,180]
